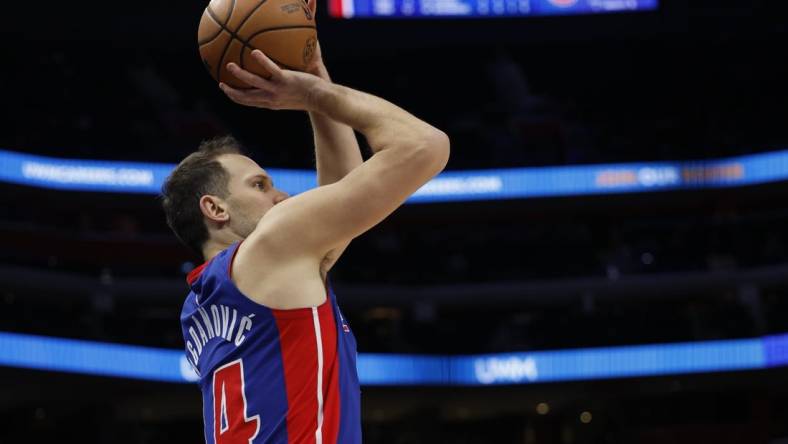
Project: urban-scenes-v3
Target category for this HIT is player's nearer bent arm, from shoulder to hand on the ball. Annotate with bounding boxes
[222,51,449,306]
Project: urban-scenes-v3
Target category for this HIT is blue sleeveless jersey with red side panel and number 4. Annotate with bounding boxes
[181,243,361,444]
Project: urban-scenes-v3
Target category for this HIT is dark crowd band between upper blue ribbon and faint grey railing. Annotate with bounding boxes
[0,186,788,285]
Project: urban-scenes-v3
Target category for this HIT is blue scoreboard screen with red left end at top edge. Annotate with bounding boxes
[329,0,659,18]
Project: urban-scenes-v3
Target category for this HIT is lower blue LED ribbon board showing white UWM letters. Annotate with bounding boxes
[0,333,788,386]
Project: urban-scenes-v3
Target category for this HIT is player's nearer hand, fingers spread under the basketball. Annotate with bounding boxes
[219,49,322,111]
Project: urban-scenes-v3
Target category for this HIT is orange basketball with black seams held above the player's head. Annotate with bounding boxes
[197,0,317,88]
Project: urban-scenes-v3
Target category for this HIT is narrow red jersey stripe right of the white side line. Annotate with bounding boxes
[320,295,340,444]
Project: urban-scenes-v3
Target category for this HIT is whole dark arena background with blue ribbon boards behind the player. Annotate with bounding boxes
[0,0,788,444]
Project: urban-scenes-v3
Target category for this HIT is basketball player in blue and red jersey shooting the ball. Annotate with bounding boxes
[162,34,449,444]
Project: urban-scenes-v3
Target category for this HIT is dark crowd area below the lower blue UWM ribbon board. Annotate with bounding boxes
[0,372,788,444]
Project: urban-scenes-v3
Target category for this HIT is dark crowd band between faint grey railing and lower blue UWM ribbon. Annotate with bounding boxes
[0,269,788,355]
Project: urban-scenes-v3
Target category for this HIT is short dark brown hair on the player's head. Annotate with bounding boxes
[161,136,244,256]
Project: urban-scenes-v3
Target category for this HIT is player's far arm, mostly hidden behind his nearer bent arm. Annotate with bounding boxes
[308,37,364,274]
